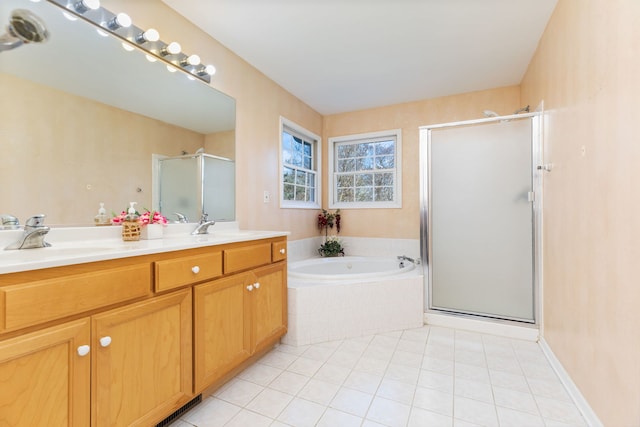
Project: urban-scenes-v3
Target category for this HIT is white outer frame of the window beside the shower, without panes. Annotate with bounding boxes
[328,129,402,209]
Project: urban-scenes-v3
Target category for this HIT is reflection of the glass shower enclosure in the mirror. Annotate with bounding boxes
[158,153,235,222]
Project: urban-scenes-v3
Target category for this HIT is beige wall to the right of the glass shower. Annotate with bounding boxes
[521,0,640,426]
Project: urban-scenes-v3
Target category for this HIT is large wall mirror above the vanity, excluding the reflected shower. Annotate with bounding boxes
[0,0,235,225]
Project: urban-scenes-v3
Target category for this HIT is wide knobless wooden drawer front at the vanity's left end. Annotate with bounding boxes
[0,263,151,330]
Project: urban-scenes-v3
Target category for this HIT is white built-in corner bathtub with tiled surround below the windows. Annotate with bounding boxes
[282,257,424,346]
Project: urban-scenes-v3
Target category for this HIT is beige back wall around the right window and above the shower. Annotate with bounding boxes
[322,86,521,239]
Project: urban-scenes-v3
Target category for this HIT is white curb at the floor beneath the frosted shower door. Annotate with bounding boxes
[424,313,539,341]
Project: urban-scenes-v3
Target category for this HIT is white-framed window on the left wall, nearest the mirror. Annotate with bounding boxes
[280,117,322,209]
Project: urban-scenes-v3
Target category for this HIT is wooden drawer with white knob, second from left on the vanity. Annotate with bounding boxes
[155,252,222,292]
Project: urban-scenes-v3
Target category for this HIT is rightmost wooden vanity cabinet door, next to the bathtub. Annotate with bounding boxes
[251,263,287,353]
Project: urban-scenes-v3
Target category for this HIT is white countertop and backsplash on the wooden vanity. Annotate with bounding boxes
[0,222,289,276]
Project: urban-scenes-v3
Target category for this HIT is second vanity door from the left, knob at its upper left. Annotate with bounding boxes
[91,289,192,426]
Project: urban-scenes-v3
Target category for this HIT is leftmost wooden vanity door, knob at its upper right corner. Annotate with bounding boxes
[0,318,91,427]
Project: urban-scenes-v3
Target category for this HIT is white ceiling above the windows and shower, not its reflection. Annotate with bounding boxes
[163,0,557,115]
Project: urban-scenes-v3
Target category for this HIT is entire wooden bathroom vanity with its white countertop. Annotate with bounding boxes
[0,227,287,427]
